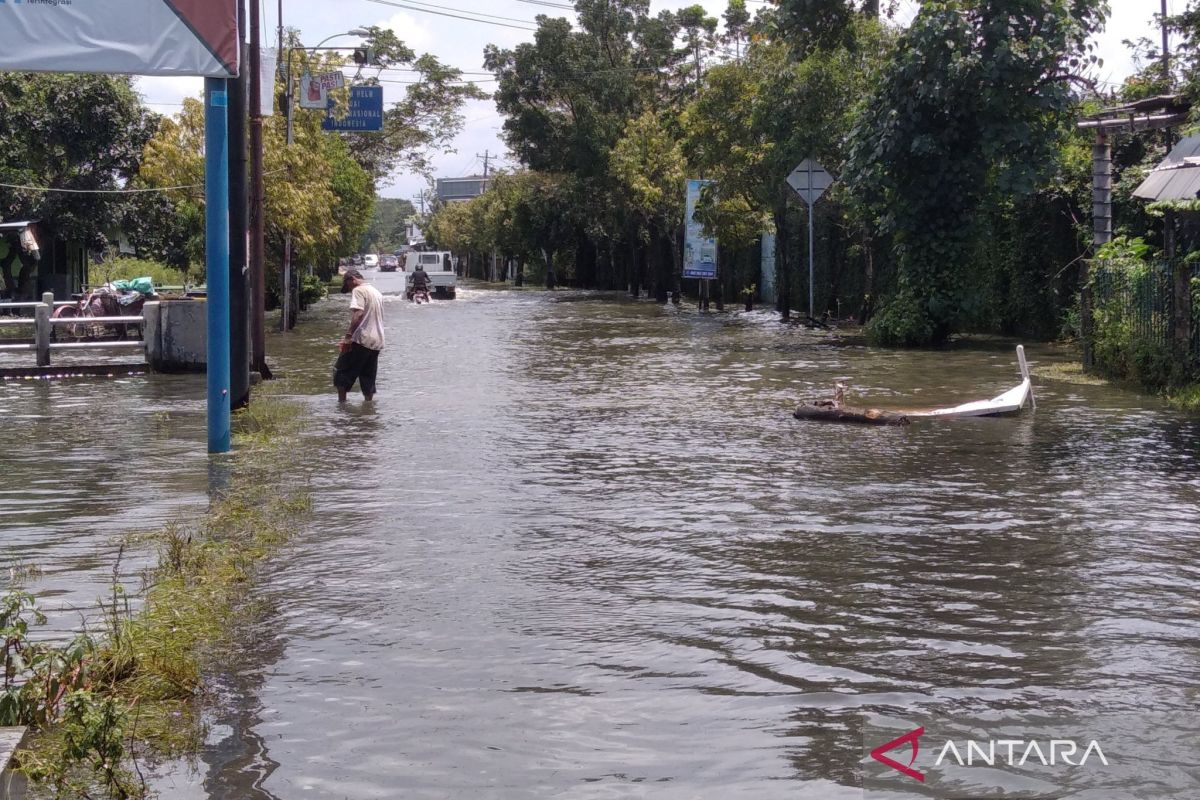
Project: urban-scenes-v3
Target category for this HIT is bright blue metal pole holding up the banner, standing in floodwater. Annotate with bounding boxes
[204,78,229,453]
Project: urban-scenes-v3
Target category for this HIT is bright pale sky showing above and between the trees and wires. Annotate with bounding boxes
[138,0,1171,199]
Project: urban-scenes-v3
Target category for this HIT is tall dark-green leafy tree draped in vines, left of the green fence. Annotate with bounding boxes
[846,0,1104,345]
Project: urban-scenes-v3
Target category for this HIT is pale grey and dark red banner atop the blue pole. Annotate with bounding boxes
[0,0,240,78]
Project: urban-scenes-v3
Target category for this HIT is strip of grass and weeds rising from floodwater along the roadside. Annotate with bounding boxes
[9,392,311,800]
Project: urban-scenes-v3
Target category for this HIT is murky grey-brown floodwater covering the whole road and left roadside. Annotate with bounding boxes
[0,275,1200,800]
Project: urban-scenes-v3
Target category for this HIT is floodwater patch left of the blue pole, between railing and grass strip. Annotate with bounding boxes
[0,375,208,634]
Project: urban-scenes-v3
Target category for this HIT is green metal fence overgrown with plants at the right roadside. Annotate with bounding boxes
[1091,260,1200,379]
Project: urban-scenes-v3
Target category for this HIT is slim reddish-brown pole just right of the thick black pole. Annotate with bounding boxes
[250,2,271,380]
